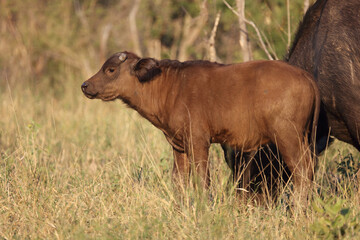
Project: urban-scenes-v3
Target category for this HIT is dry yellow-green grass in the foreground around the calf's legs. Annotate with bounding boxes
[0,74,360,239]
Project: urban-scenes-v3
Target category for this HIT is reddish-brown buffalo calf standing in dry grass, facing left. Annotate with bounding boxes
[82,52,319,195]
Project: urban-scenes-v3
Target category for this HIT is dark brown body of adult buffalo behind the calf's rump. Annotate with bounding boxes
[286,0,360,151]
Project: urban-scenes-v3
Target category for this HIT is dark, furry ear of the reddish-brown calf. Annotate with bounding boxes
[133,58,161,82]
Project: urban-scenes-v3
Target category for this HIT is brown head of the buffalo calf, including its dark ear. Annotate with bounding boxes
[81,52,161,101]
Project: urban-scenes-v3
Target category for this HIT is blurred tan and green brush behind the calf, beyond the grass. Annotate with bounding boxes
[0,0,312,95]
